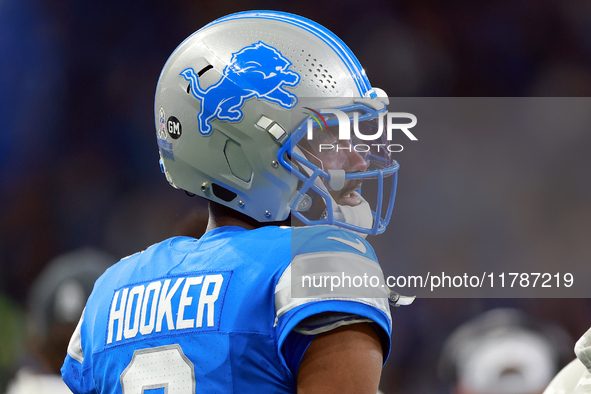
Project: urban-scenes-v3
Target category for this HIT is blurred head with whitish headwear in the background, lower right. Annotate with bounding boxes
[439,308,571,394]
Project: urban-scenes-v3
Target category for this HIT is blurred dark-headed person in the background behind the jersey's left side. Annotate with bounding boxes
[6,247,116,394]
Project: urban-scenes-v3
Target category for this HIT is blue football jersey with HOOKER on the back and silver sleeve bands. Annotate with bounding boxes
[62,226,391,394]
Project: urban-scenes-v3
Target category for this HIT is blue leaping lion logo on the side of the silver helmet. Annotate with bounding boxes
[180,41,300,135]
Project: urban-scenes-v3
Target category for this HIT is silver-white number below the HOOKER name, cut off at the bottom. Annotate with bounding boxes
[121,345,195,394]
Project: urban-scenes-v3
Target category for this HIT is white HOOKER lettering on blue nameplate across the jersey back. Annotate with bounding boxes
[105,271,231,347]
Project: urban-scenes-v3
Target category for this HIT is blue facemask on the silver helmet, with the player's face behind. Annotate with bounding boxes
[279,98,399,235]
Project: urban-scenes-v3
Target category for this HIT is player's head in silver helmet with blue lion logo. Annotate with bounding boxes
[154,11,398,234]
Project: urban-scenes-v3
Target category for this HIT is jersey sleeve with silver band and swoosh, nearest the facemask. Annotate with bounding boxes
[275,228,392,375]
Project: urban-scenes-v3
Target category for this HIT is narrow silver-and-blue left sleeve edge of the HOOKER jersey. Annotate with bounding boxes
[61,312,97,394]
